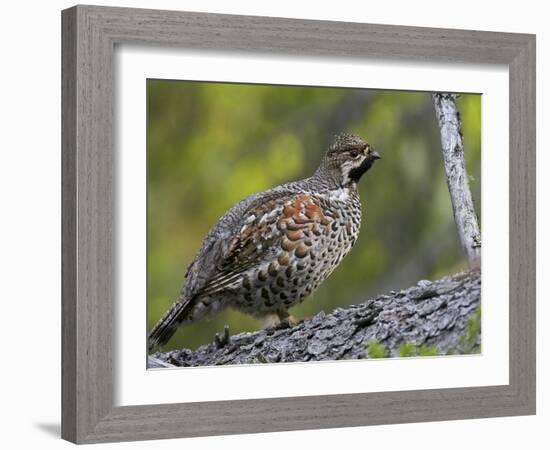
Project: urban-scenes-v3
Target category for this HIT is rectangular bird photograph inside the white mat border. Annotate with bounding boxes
[146,81,484,367]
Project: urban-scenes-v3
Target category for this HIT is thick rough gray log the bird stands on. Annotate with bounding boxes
[148,271,481,368]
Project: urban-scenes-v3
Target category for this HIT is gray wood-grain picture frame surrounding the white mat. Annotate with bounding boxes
[62,6,535,443]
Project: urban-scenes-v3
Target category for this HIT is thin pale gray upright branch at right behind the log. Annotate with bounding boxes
[432,93,481,269]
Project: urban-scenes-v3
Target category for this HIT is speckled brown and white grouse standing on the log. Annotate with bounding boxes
[148,133,381,351]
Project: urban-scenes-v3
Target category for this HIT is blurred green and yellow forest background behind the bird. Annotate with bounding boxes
[147,80,481,350]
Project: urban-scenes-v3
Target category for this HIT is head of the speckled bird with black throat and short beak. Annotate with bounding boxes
[319,133,381,187]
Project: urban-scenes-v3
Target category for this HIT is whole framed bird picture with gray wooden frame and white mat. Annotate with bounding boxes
[62,6,535,443]
